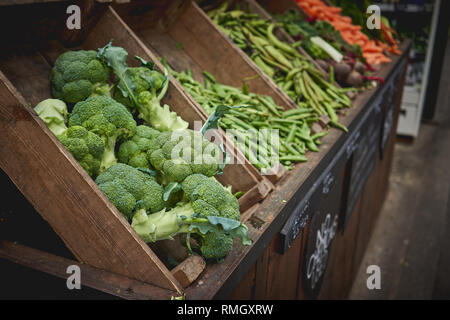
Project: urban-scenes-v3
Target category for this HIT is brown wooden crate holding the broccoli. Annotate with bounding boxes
[0,0,270,295]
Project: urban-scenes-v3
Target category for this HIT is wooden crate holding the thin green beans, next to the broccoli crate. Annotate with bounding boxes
[115,1,296,182]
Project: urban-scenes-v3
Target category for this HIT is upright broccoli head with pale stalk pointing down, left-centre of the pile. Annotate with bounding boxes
[69,96,136,173]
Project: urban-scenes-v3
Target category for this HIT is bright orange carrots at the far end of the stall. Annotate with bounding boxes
[296,0,399,65]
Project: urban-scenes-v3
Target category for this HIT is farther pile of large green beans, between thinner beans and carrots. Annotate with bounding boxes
[208,2,351,132]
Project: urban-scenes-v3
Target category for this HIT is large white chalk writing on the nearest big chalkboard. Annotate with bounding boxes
[306,213,338,290]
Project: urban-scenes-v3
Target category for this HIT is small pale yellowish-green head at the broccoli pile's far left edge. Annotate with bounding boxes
[34,99,69,136]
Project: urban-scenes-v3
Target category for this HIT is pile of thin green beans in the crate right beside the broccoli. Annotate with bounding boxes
[167,67,328,169]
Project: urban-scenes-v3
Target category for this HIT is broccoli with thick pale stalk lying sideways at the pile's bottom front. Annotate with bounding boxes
[132,174,251,260]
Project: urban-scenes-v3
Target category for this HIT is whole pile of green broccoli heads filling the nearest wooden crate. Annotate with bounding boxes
[35,42,251,261]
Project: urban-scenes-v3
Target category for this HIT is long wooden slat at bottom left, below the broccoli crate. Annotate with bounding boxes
[0,240,179,300]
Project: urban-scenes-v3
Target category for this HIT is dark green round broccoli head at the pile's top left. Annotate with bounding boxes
[50,50,109,103]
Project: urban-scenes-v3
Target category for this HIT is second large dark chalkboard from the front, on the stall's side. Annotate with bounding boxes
[340,95,383,228]
